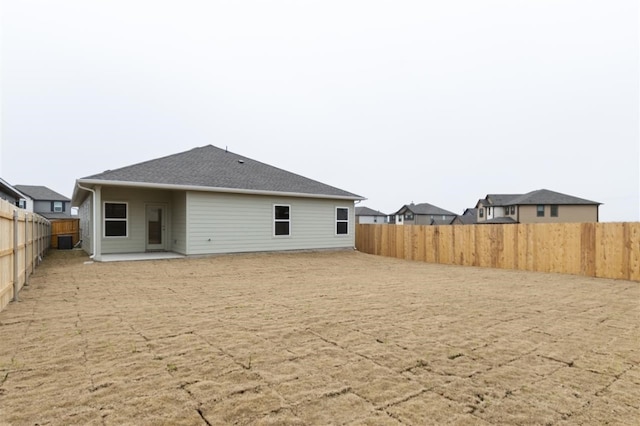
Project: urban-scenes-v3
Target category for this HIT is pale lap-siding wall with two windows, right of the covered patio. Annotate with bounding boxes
[186,192,355,255]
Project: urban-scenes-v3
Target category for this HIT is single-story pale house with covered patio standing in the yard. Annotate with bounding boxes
[72,145,364,260]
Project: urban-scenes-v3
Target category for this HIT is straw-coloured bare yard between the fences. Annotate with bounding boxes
[0,251,640,425]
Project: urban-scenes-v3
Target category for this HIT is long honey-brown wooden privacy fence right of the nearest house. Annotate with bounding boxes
[356,222,640,281]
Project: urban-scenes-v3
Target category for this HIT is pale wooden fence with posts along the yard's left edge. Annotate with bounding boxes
[0,200,51,311]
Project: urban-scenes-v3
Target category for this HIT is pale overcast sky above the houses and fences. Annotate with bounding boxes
[0,0,640,221]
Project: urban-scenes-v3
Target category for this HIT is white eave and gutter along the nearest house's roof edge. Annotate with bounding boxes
[72,179,366,207]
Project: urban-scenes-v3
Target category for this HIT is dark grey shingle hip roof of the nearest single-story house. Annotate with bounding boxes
[80,145,363,199]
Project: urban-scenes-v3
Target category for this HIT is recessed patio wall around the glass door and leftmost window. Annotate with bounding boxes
[98,186,173,254]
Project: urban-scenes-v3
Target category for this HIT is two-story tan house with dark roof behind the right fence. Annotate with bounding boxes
[476,189,601,224]
